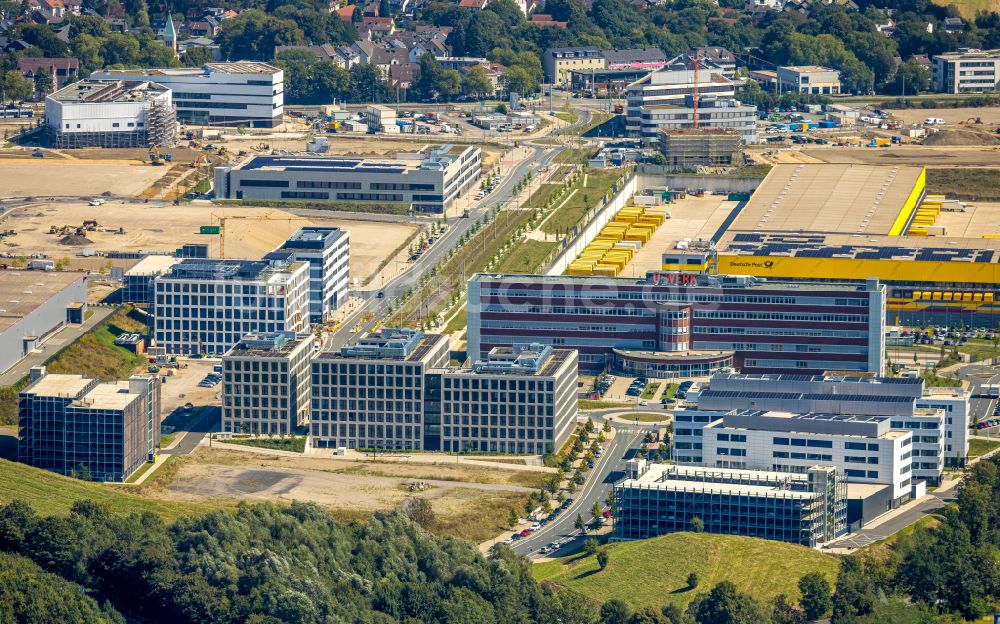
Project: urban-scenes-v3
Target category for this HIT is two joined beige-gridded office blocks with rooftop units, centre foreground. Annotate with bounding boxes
[311,329,577,455]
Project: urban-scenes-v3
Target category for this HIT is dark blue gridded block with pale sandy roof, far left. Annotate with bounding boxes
[18,367,160,481]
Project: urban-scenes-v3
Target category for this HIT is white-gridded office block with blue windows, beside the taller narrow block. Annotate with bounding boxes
[154,259,309,356]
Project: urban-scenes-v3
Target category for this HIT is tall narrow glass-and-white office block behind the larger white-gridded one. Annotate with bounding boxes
[264,226,351,323]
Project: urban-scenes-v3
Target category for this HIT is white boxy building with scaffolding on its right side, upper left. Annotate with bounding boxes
[45,79,177,148]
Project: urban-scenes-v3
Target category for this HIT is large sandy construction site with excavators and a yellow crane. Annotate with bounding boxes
[0,202,416,280]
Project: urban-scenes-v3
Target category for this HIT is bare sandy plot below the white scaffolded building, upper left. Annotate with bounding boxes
[0,157,166,197]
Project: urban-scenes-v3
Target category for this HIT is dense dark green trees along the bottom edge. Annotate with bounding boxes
[0,459,1000,624]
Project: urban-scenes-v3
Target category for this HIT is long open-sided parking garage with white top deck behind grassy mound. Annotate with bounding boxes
[612,459,847,548]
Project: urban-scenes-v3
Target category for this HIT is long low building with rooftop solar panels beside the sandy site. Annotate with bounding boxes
[215,145,482,214]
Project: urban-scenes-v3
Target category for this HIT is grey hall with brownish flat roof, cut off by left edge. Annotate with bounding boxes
[0,270,87,373]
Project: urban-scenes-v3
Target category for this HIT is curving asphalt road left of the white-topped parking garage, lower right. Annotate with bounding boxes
[511,424,645,555]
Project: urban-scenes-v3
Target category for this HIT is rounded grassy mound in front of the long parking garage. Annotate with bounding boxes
[532,533,840,608]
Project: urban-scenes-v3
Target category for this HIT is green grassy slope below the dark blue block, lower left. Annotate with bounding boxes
[0,459,231,521]
